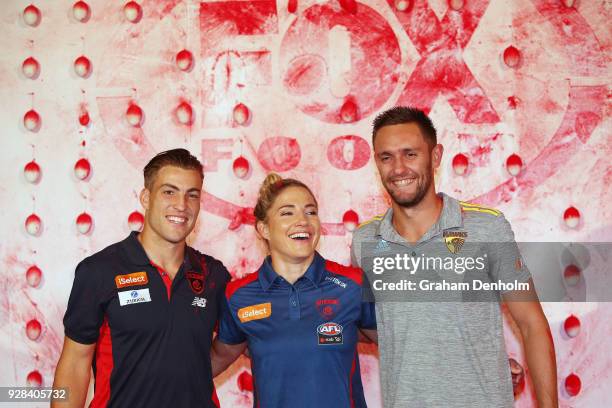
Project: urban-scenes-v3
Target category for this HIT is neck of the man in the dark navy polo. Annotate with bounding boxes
[138,228,186,279]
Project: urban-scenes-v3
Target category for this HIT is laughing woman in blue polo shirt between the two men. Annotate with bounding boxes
[211,174,376,407]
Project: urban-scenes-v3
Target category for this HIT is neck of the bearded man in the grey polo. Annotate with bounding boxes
[391,191,444,244]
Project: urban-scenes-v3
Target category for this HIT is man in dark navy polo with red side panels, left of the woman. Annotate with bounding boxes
[53,149,230,408]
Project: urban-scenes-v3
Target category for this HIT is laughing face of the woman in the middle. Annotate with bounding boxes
[257,186,321,262]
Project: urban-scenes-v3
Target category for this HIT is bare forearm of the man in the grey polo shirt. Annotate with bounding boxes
[521,323,558,408]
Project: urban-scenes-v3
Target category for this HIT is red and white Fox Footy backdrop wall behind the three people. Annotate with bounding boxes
[0,0,612,407]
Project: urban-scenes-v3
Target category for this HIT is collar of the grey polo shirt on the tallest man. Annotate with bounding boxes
[376,193,463,242]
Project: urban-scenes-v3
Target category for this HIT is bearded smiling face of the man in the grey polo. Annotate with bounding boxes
[374,123,442,207]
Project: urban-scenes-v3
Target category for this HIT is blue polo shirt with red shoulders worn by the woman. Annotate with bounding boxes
[219,253,376,408]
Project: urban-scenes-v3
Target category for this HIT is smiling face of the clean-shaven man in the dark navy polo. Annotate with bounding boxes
[140,166,203,244]
